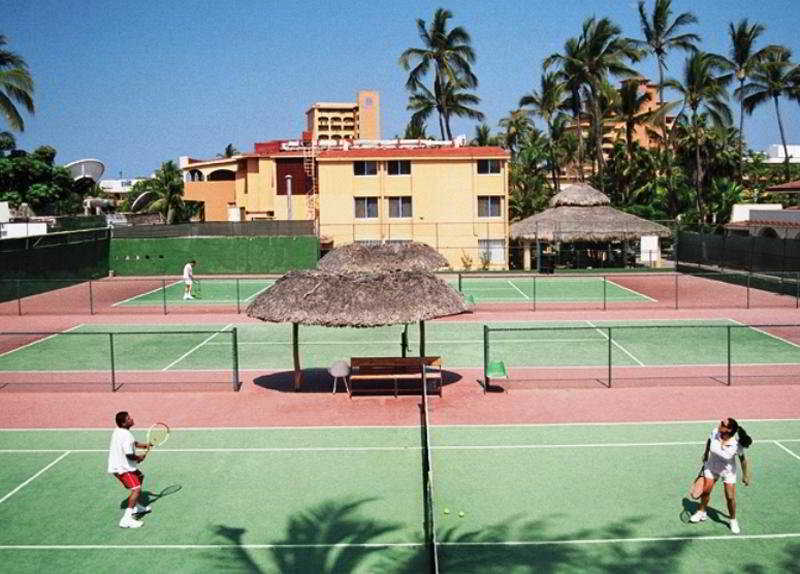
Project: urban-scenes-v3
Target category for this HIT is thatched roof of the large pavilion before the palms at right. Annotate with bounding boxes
[511,184,672,243]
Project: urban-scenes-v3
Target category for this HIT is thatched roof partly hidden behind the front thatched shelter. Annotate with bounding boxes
[317,242,448,273]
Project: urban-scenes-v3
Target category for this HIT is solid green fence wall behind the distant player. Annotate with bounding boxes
[109,235,319,275]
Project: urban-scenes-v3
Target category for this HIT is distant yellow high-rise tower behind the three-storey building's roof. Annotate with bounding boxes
[304,91,381,142]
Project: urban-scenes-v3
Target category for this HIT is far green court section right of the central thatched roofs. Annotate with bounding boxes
[448,276,654,303]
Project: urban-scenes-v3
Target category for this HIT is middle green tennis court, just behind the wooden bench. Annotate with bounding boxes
[0,320,800,372]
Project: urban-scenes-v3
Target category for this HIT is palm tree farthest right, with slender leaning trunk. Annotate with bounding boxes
[736,47,800,173]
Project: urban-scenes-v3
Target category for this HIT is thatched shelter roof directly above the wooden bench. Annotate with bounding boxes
[247,271,467,327]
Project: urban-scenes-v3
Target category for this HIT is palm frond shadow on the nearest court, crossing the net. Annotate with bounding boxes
[198,499,700,574]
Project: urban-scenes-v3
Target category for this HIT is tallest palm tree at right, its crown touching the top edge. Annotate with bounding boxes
[636,0,700,143]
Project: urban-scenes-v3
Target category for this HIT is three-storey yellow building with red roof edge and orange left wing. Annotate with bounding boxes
[181,140,509,269]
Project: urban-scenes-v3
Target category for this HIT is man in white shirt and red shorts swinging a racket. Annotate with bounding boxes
[108,411,150,528]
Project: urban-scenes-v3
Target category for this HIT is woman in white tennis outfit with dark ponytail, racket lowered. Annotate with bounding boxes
[689,418,753,534]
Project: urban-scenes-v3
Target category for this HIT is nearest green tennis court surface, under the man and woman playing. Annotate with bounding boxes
[0,420,800,573]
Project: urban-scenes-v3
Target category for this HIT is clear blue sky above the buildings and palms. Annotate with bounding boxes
[6,0,800,178]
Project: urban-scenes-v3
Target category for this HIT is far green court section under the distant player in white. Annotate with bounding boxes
[114,279,275,307]
